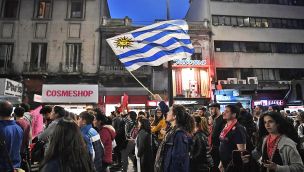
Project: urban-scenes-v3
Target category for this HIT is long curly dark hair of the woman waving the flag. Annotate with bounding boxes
[172,105,194,134]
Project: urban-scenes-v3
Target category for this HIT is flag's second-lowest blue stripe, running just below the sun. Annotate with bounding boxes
[118,38,191,59]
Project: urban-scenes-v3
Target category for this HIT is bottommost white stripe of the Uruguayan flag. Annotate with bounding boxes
[126,52,192,71]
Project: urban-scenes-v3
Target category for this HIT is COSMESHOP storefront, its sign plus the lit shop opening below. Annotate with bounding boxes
[41,84,98,114]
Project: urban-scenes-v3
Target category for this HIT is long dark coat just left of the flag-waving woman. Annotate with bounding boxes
[136,129,154,172]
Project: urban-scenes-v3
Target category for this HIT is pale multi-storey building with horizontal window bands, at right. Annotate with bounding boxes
[186,0,304,107]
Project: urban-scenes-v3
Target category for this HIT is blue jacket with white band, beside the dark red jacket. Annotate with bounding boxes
[80,124,104,172]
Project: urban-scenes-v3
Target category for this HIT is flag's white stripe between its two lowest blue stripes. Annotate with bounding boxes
[119,42,193,63]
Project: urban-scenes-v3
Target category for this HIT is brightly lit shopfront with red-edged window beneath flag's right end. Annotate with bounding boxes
[172,40,211,104]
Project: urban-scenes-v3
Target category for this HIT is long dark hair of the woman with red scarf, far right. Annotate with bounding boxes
[259,111,299,144]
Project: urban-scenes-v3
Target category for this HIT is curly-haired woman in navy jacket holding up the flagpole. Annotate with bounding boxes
[154,94,194,172]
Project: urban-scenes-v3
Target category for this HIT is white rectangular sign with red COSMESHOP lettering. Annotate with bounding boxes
[42,84,98,103]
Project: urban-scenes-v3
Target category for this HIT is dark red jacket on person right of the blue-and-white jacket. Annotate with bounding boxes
[99,125,116,164]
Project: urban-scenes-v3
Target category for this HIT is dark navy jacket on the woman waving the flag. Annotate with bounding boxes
[163,129,191,172]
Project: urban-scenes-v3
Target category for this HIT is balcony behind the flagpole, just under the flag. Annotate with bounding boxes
[99,65,152,75]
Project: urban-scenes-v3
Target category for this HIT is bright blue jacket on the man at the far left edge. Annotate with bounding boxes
[0,120,23,171]
